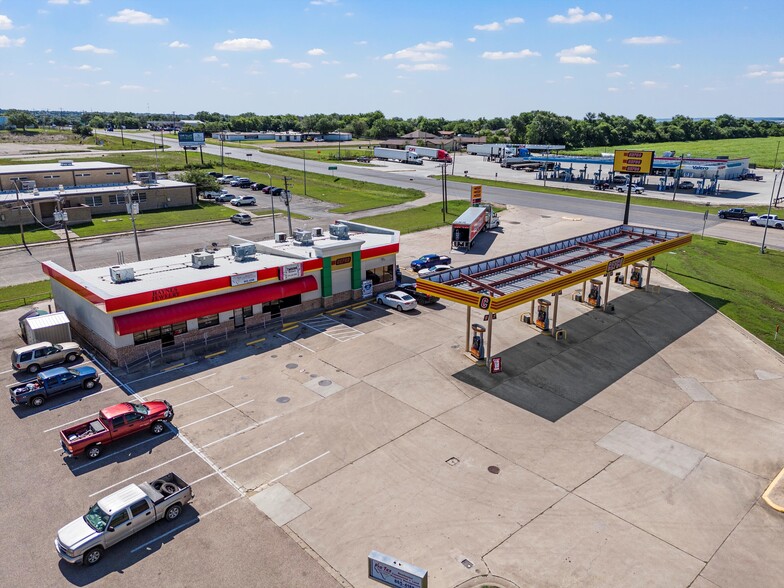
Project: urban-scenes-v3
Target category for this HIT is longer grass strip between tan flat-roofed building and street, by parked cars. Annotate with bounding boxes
[71,202,236,237]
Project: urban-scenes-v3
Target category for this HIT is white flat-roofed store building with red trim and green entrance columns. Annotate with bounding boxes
[42,221,400,365]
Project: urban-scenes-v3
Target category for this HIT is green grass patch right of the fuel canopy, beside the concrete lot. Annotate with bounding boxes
[654,238,784,353]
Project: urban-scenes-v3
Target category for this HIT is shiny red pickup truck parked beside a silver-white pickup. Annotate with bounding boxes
[60,400,174,459]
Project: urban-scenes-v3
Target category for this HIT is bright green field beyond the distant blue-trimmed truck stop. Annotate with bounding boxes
[563,137,784,169]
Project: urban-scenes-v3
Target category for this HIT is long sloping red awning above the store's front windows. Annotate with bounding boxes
[114,276,318,335]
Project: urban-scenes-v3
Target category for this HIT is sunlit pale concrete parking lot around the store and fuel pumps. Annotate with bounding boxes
[0,207,784,587]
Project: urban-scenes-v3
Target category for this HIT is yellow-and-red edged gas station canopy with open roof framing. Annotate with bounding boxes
[416,225,691,312]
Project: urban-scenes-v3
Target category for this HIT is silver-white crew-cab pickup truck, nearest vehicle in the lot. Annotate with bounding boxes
[54,473,193,566]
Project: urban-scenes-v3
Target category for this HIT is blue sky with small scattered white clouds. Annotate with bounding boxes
[0,0,784,119]
